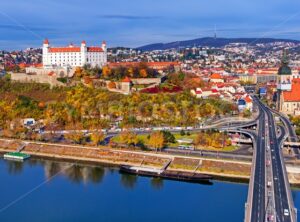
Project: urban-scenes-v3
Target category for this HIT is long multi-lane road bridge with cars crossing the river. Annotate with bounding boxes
[245,97,297,222]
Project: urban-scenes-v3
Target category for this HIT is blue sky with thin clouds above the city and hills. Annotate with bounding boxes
[0,0,300,50]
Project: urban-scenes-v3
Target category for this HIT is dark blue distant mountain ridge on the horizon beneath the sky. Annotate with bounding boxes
[137,37,300,51]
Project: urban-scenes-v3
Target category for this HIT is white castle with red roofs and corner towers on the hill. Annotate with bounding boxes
[43,39,107,68]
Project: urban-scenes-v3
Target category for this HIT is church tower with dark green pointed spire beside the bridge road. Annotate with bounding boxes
[277,49,292,111]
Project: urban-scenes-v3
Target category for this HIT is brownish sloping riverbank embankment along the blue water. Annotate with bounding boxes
[0,139,300,185]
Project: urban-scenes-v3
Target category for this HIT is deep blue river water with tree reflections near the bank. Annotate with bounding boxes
[0,159,300,222]
